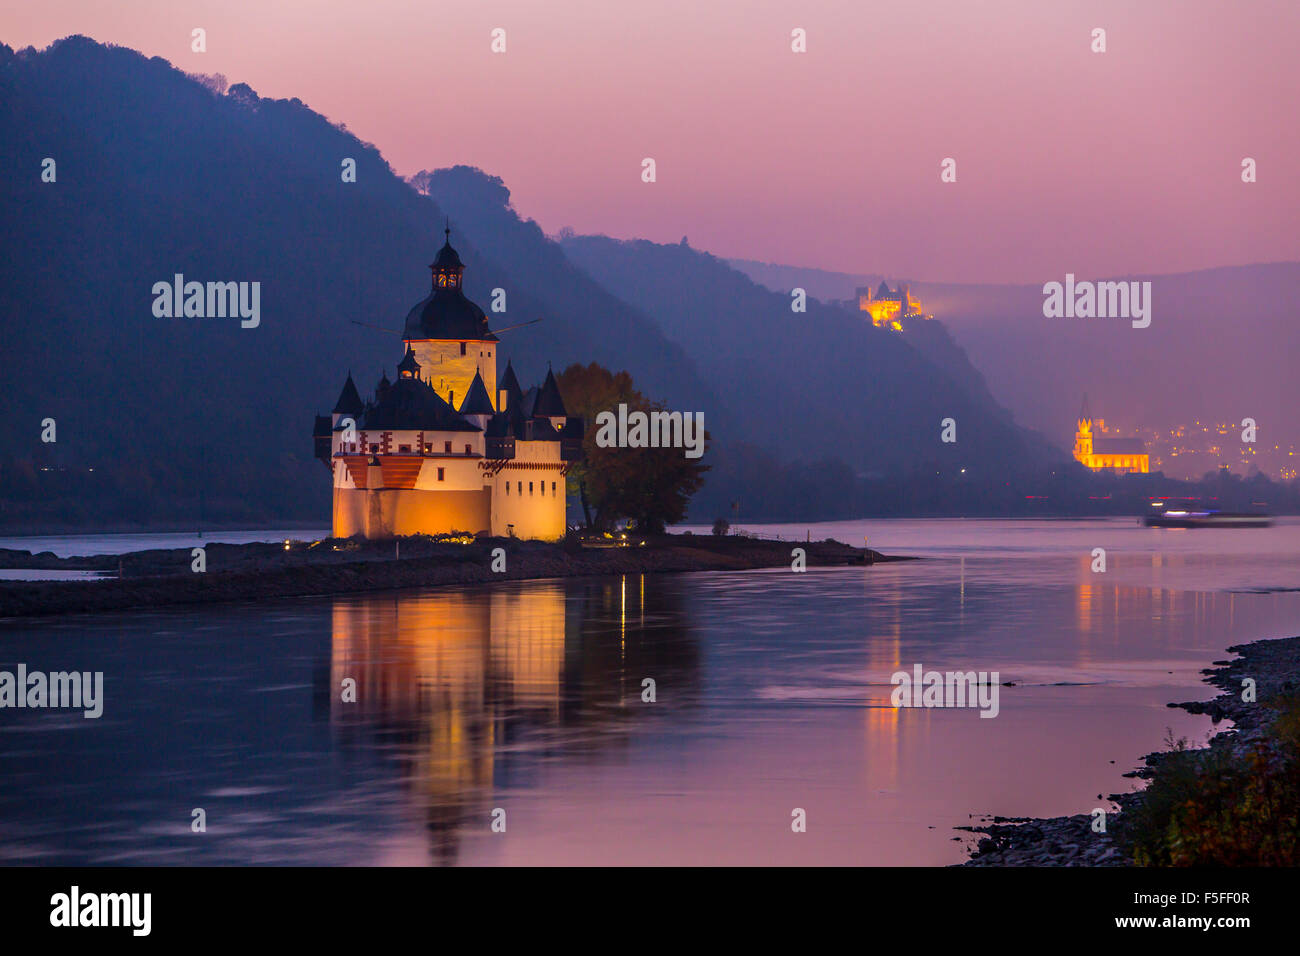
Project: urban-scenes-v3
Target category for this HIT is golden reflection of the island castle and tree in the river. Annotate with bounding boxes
[319,576,699,864]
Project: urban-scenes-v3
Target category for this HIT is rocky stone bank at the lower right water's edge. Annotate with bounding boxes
[957,637,1300,866]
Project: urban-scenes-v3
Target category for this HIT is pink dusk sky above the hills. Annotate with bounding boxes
[0,0,1300,284]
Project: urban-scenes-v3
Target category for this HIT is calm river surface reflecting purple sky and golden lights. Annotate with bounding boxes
[0,520,1300,865]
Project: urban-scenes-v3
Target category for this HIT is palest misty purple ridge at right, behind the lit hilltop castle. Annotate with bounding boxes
[731,260,1300,460]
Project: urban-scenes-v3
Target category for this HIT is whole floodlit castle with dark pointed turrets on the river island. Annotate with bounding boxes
[313,226,584,540]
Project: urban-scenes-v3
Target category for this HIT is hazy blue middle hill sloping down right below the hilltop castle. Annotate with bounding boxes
[563,235,1060,479]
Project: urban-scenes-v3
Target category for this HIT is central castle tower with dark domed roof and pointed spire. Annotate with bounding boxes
[402,225,498,416]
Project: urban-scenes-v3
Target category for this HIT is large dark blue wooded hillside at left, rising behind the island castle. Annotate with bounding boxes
[0,36,725,529]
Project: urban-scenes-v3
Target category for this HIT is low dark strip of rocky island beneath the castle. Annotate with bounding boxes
[0,535,905,618]
